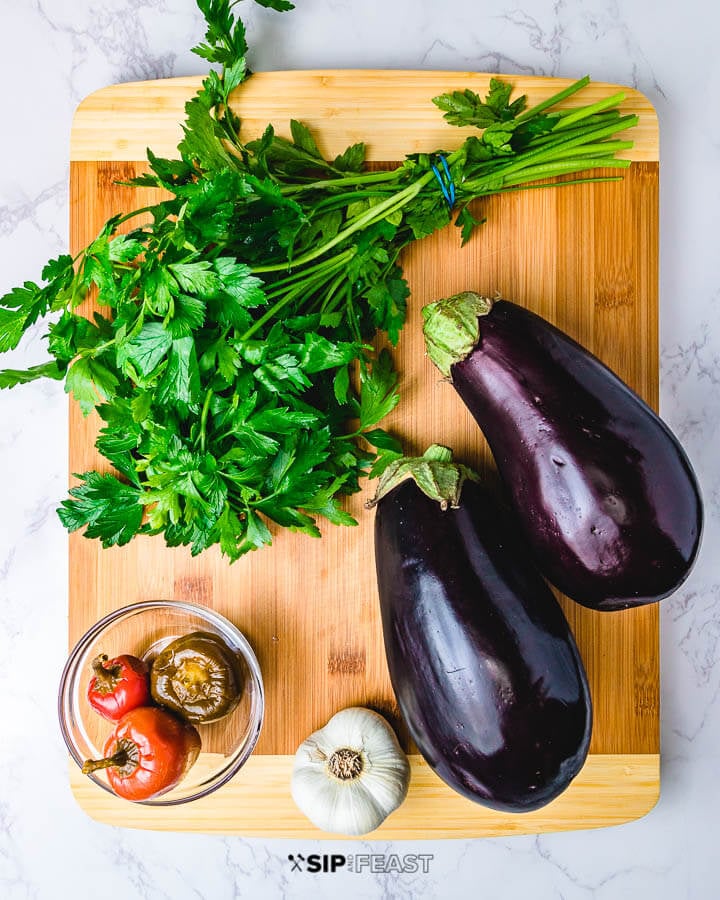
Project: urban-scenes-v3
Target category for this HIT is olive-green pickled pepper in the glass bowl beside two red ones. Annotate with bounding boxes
[150,631,243,723]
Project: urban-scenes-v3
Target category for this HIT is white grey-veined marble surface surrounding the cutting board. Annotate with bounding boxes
[0,0,720,900]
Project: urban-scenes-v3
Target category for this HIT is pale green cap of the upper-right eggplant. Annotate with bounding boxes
[422,291,493,378]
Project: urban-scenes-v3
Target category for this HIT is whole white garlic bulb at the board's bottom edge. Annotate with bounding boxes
[291,706,410,835]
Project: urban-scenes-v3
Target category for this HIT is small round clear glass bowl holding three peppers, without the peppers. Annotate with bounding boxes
[58,600,265,806]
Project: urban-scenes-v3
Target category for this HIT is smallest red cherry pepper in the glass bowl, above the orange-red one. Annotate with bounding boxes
[87,653,152,722]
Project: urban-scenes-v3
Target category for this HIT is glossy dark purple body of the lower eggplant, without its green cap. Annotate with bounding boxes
[375,480,592,813]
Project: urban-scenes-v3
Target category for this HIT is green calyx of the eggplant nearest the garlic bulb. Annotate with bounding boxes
[365,444,480,510]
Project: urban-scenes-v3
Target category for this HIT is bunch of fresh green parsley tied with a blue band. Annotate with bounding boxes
[0,0,637,560]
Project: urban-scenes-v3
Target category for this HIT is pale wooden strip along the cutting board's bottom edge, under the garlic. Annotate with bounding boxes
[70,754,660,842]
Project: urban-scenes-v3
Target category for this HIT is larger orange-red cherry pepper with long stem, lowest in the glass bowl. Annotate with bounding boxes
[82,706,200,800]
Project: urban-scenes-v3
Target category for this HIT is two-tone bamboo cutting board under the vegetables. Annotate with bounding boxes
[69,71,659,839]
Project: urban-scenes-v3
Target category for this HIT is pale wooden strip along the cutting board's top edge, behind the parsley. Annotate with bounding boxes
[70,69,658,162]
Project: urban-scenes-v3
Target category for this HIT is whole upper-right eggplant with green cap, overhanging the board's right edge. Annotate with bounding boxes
[423,292,703,610]
